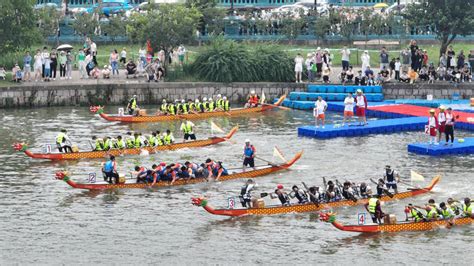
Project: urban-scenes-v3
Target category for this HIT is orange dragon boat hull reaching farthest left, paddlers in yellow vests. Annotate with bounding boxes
[13,127,238,160]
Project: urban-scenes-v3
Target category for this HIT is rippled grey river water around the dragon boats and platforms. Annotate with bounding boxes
[0,107,474,265]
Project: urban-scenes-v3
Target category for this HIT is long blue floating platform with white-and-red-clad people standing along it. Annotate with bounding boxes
[298,117,426,139]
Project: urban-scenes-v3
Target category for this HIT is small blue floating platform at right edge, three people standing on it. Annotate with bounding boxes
[408,138,474,156]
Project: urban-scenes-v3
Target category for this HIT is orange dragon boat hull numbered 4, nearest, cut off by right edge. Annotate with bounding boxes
[320,213,474,233]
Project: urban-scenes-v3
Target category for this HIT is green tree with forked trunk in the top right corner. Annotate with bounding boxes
[404,0,474,55]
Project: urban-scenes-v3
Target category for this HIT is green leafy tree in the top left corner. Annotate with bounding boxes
[0,0,40,54]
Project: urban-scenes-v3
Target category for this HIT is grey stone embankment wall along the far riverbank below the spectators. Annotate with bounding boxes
[0,82,474,108]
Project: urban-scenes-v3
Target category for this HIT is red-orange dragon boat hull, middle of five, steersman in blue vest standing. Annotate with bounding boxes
[52,151,303,190]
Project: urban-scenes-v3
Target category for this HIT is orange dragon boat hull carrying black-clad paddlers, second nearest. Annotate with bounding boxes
[192,176,441,216]
